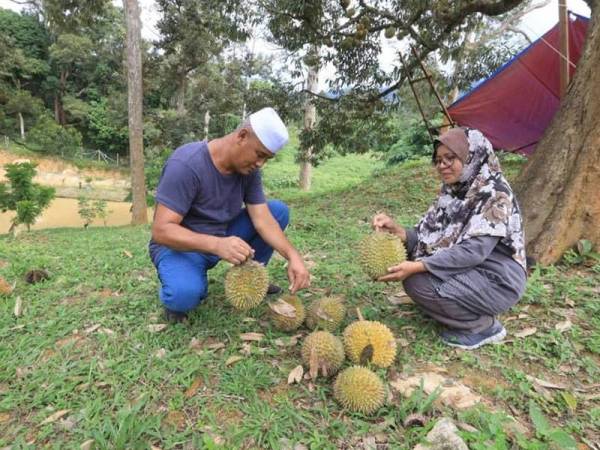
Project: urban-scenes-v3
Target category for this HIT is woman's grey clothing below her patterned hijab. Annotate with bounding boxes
[404,269,520,333]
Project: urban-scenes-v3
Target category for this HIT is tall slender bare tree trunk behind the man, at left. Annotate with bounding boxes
[124,0,148,225]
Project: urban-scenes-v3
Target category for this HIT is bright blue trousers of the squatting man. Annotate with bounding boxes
[156,200,289,312]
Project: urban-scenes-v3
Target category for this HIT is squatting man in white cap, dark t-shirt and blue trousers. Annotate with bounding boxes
[150,108,310,322]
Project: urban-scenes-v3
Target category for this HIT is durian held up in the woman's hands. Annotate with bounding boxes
[358,231,406,280]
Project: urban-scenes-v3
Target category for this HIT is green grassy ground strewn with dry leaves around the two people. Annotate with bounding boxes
[0,152,600,449]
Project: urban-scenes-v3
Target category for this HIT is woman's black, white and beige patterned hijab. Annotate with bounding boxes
[414,129,526,269]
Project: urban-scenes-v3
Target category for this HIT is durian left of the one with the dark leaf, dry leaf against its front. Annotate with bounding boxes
[302,331,345,379]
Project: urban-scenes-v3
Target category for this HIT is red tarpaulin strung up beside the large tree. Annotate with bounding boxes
[448,13,589,154]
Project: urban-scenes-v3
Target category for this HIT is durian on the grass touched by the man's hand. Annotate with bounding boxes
[225,261,269,311]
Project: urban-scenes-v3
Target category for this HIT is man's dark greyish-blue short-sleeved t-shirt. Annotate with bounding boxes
[150,141,266,261]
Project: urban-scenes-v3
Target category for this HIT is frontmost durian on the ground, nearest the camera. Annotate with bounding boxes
[333,366,385,414]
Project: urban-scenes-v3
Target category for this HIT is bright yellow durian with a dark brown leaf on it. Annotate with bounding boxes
[343,320,396,368]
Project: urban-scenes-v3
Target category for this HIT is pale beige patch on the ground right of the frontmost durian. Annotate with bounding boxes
[390,372,481,409]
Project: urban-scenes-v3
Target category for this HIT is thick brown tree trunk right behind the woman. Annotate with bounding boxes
[515,4,600,264]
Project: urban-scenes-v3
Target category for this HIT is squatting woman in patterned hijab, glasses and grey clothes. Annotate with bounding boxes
[372,128,527,349]
